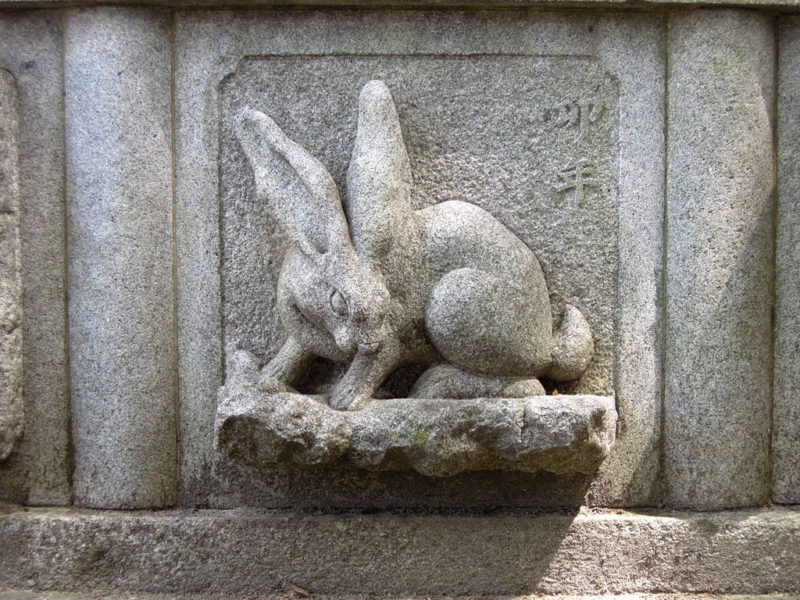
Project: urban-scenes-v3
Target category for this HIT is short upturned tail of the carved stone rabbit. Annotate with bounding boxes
[547,304,594,381]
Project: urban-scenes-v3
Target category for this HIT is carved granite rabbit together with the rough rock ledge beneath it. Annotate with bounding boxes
[217,81,616,476]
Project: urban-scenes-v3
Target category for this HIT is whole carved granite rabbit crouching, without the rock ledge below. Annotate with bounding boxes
[237,81,593,409]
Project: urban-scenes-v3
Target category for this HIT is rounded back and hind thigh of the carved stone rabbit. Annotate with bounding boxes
[420,201,553,377]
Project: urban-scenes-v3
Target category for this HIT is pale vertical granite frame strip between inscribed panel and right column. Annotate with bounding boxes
[587,15,666,506]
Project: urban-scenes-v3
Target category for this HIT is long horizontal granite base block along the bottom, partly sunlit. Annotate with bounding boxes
[0,506,800,597]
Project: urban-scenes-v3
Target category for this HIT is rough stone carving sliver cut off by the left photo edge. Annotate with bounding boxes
[0,69,24,461]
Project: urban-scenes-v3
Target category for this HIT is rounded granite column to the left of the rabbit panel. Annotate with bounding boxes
[65,8,177,508]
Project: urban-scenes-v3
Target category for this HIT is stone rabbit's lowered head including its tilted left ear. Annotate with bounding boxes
[237,109,390,361]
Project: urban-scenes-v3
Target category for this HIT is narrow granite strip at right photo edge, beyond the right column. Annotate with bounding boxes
[772,17,800,504]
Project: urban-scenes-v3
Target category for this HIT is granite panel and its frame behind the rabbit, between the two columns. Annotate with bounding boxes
[180,11,663,506]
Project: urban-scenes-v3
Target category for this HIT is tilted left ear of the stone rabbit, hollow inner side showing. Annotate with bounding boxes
[237,108,350,257]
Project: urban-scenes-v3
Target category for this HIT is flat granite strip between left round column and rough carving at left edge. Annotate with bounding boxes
[0,11,70,505]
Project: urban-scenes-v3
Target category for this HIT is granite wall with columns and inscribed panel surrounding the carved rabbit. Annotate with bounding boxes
[0,0,800,594]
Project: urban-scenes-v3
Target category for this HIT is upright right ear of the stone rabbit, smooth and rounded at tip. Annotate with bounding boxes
[346,81,412,262]
